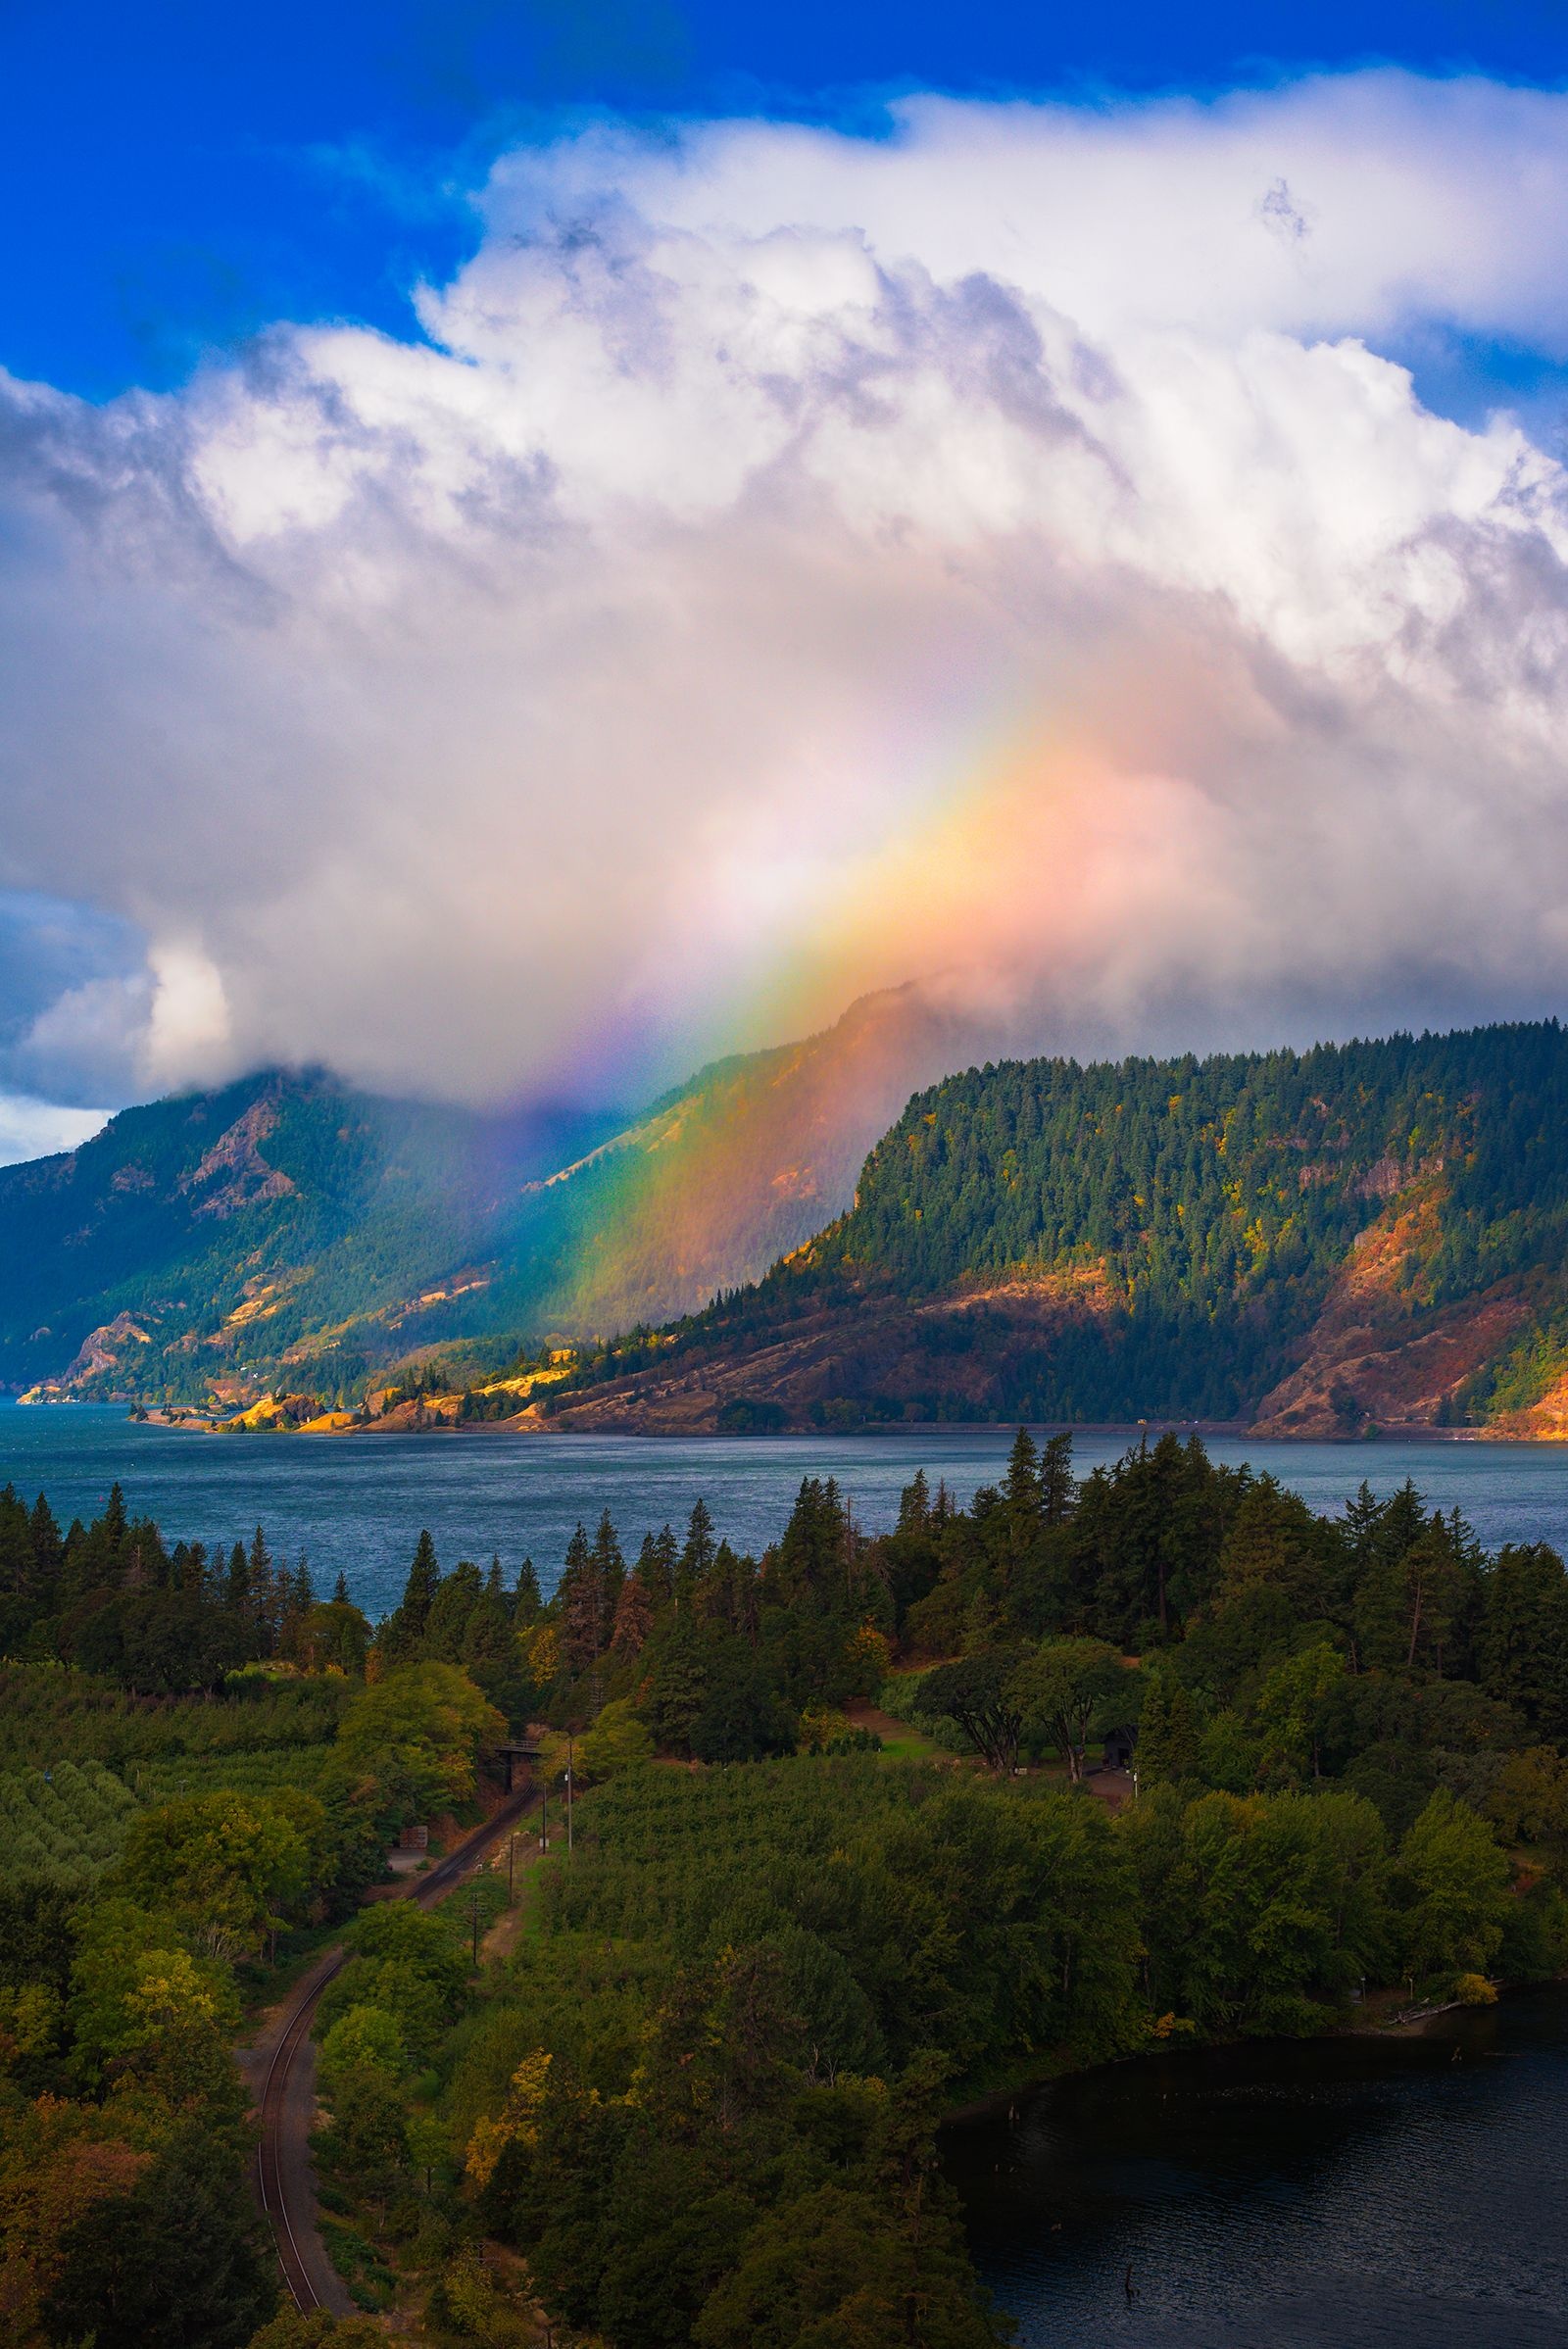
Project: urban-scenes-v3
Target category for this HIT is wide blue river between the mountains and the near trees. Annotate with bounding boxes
[0,1402,1568,1616]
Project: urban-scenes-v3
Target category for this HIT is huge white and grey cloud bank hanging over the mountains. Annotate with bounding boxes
[0,73,1568,1101]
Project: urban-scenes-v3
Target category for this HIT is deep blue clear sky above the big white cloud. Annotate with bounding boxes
[0,0,1568,399]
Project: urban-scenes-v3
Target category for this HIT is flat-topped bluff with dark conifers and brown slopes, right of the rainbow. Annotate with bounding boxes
[535,1024,1568,1436]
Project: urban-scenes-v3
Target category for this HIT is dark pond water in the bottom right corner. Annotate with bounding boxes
[946,1989,1568,2349]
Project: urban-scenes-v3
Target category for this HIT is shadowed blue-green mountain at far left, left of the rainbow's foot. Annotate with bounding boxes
[0,1071,532,1397]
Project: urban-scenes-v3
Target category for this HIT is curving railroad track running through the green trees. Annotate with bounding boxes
[256,1787,528,2316]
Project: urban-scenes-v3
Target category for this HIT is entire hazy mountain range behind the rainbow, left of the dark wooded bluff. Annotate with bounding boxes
[0,989,967,1402]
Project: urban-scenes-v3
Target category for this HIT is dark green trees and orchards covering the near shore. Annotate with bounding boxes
[0,1431,1568,2349]
